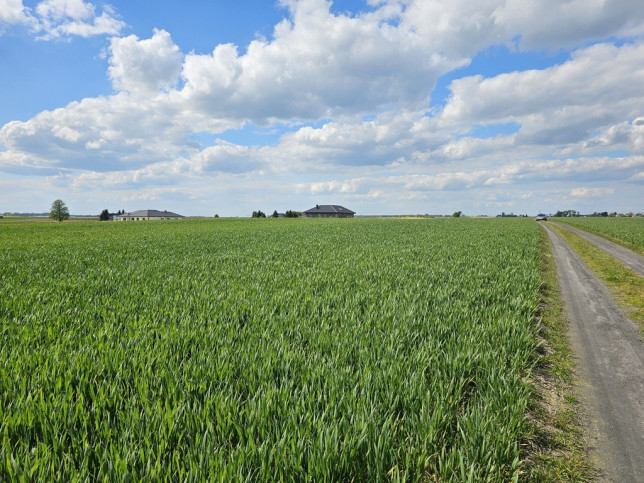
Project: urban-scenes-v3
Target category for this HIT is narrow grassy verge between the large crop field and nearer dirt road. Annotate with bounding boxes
[522,230,595,482]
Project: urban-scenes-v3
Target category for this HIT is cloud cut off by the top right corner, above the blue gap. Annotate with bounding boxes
[394,0,644,57]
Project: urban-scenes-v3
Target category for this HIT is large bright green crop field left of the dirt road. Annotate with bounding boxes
[0,218,540,481]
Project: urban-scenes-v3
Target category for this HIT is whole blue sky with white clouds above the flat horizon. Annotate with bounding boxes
[0,0,644,216]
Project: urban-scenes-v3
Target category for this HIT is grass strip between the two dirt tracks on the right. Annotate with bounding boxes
[554,226,644,333]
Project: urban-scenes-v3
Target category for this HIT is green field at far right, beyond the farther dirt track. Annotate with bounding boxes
[552,217,644,254]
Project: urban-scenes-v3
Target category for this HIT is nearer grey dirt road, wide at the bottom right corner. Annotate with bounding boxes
[542,224,644,482]
